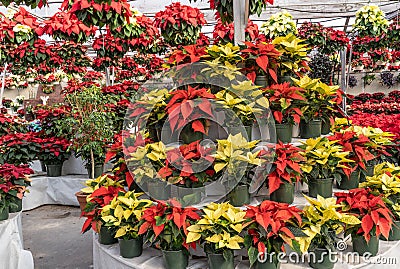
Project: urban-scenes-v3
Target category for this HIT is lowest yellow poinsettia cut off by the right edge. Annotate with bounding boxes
[360,162,400,241]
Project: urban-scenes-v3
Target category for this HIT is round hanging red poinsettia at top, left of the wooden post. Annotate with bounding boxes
[155,2,206,47]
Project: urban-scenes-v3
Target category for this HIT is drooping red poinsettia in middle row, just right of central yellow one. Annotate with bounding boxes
[267,141,305,194]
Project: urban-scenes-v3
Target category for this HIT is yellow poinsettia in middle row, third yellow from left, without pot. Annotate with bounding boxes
[300,137,353,180]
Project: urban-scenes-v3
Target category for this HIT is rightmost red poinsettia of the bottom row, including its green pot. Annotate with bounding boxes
[335,189,393,256]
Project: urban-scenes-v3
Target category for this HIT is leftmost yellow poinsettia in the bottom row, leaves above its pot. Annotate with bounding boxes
[101,191,153,240]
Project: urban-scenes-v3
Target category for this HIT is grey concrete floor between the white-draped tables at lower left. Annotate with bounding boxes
[22,205,93,269]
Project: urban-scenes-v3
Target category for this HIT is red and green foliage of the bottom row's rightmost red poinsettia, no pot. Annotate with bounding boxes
[335,186,393,242]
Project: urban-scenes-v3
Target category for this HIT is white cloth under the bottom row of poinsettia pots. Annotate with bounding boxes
[93,234,400,269]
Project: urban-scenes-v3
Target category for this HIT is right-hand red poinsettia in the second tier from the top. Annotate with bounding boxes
[265,82,306,123]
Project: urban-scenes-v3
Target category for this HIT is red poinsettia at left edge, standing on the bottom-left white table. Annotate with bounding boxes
[0,163,33,215]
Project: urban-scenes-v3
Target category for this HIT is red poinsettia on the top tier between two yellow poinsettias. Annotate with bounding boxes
[241,42,281,84]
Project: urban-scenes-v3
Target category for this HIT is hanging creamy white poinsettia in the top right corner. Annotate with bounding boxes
[353,5,389,37]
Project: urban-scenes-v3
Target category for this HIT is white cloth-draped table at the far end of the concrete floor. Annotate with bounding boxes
[22,175,87,210]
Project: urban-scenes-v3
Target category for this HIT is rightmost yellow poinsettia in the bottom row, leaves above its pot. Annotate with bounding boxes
[296,195,361,253]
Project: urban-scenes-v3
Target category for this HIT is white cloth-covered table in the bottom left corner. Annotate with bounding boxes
[0,212,34,269]
